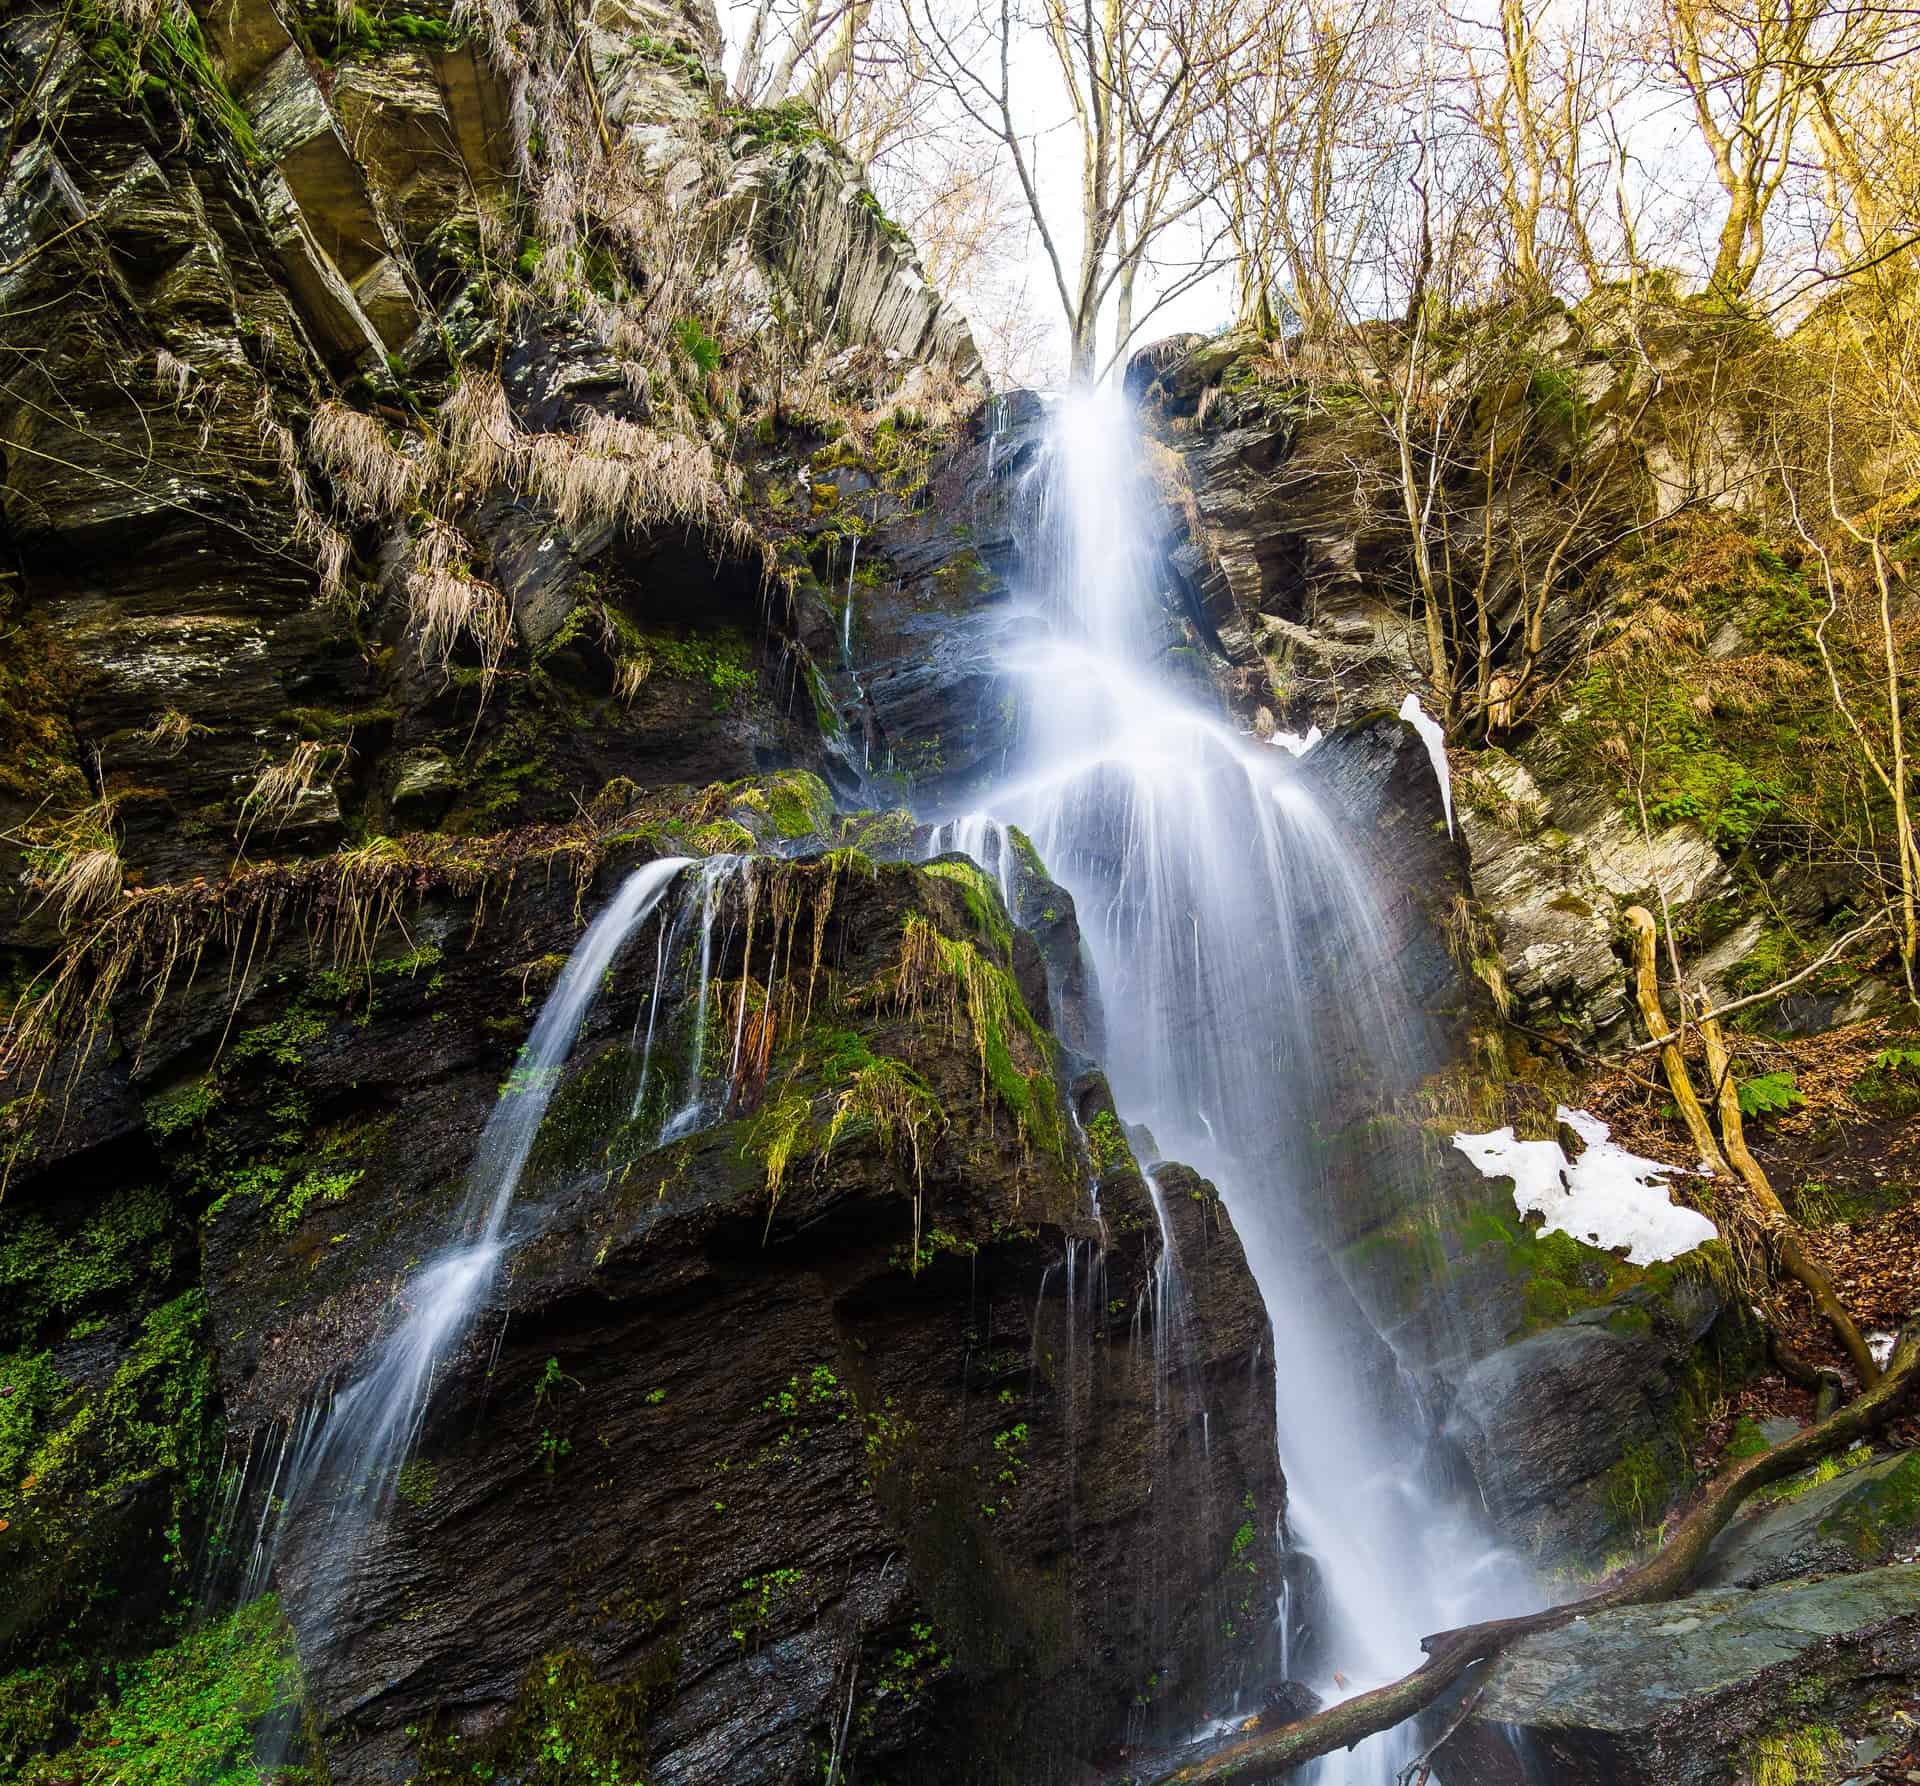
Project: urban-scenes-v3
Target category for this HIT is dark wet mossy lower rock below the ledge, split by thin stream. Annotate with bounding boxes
[0,784,1283,1782]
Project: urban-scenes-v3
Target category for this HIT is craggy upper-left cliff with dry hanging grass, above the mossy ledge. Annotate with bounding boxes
[0,0,979,917]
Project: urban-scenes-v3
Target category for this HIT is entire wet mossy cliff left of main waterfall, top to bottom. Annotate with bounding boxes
[0,0,1284,1786]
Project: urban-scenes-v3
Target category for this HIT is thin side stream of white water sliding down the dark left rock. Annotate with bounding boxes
[246,857,691,1629]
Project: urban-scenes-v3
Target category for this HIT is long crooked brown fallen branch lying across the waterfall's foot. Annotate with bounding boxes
[1154,1321,1920,1786]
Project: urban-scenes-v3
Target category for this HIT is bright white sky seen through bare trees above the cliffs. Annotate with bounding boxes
[724,0,1920,382]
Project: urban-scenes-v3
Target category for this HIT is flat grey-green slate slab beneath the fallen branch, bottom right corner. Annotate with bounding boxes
[1440,1565,1920,1786]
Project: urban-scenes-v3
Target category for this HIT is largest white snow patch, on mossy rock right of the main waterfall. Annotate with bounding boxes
[1453,1104,1720,1266]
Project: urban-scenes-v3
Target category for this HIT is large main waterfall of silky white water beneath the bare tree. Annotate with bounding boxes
[935,392,1534,1786]
